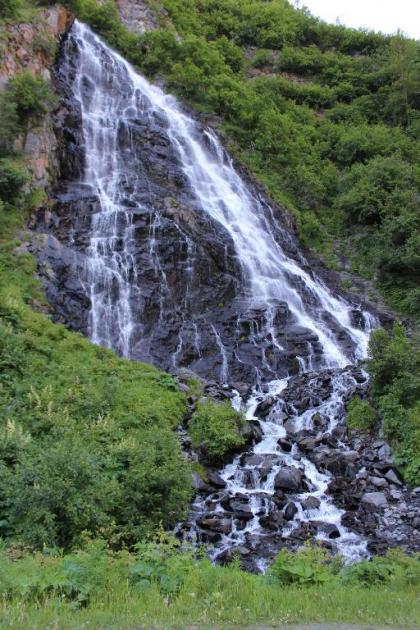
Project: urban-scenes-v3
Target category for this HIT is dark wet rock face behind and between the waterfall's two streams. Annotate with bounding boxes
[32,23,374,382]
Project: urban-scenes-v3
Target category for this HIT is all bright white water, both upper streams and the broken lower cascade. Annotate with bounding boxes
[71,21,374,558]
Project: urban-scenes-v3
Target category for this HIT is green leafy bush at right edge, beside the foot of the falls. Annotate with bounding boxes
[368,324,420,485]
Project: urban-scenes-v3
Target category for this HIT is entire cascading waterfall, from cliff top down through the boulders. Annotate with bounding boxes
[55,21,374,572]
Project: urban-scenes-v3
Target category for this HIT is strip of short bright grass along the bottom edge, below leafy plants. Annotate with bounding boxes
[0,588,420,630]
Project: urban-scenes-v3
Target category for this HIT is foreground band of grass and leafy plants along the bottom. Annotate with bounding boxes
[0,540,420,629]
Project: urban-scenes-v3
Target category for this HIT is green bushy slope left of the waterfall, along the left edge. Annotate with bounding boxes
[0,66,191,548]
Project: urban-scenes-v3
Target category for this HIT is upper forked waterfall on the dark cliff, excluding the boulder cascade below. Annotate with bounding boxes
[65,20,368,367]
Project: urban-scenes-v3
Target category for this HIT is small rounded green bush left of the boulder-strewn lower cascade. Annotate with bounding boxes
[188,400,245,464]
